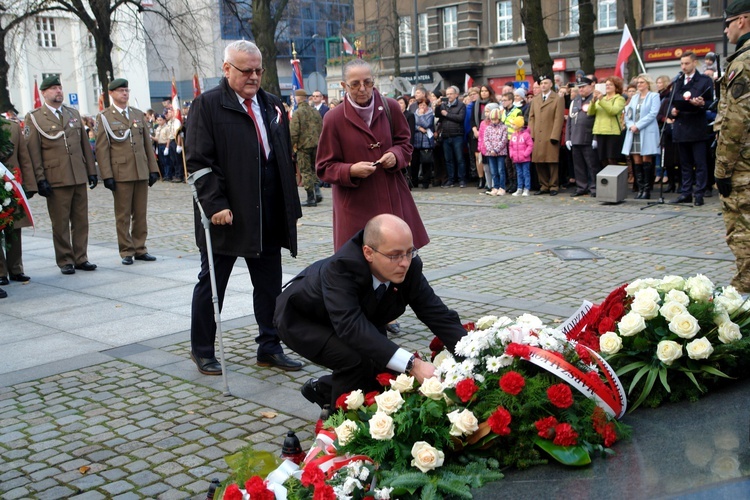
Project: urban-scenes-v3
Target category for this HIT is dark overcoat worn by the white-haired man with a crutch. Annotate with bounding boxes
[185,78,302,258]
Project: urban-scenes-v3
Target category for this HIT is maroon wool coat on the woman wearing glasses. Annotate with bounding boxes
[316,90,430,251]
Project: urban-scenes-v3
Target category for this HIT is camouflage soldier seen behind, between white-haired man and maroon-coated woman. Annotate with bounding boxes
[289,89,323,207]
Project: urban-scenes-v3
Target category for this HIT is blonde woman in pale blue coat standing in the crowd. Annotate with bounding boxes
[622,73,660,200]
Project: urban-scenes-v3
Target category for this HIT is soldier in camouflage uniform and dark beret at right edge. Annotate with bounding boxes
[714,0,750,293]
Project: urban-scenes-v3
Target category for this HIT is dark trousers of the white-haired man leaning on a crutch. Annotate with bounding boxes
[190,246,282,358]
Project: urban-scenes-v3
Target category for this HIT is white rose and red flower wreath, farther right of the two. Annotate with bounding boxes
[569,274,750,410]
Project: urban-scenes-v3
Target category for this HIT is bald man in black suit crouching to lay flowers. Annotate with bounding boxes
[274,214,466,407]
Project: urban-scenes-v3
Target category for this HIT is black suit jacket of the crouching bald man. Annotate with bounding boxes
[274,231,466,367]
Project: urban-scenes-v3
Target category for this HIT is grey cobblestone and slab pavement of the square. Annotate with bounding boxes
[0,179,734,500]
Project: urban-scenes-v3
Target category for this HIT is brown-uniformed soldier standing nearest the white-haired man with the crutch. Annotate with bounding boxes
[96,78,159,266]
